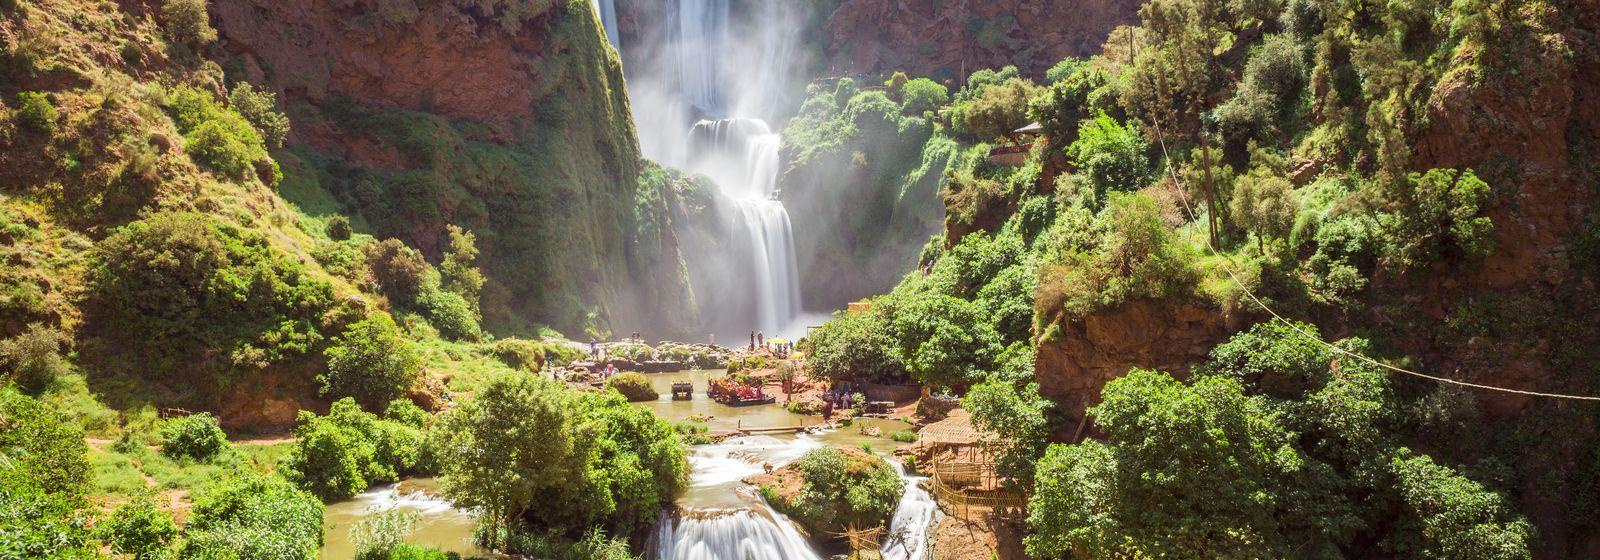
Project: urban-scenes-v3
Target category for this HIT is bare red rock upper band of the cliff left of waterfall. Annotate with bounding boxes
[211,0,550,123]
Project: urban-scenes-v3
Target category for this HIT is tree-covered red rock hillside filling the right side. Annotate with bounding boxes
[806,0,1600,558]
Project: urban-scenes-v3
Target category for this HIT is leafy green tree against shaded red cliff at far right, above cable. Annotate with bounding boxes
[1381,170,1494,269]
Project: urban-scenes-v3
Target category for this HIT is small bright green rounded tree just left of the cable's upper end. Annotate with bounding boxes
[1067,112,1152,194]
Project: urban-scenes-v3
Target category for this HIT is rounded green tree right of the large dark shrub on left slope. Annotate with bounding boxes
[317,312,422,406]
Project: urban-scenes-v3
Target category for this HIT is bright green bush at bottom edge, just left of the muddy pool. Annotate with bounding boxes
[179,472,323,560]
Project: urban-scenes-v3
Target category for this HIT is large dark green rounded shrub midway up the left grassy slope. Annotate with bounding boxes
[90,213,334,382]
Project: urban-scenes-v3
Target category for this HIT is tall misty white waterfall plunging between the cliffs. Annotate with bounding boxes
[595,0,806,344]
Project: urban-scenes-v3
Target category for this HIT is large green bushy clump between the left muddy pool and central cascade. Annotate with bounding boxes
[429,374,688,538]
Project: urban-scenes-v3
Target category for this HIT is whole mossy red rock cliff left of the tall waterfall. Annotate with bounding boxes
[208,0,686,336]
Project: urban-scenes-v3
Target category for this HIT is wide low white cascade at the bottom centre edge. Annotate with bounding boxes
[650,509,821,560]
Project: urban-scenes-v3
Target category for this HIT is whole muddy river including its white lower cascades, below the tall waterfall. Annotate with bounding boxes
[322,371,938,560]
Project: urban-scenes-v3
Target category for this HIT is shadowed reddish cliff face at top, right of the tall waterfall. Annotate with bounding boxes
[826,0,1141,77]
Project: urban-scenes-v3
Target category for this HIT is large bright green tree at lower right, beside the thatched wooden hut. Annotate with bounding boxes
[1026,370,1315,558]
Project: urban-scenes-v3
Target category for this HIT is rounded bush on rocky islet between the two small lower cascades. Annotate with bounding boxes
[768,448,906,533]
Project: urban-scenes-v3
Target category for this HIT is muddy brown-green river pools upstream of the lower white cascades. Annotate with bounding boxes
[322,371,910,558]
